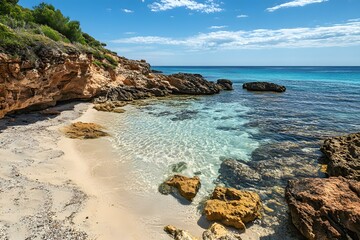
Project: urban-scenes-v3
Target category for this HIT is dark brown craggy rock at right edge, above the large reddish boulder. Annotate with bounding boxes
[320,133,360,181]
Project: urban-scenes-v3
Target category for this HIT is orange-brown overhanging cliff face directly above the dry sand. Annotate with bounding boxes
[0,50,116,117]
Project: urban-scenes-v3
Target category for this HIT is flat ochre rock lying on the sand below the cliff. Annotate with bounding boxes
[63,122,109,139]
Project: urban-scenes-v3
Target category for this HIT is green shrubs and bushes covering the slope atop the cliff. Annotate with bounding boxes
[0,0,118,69]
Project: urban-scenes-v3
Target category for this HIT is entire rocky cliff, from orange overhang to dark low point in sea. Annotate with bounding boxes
[0,47,224,118]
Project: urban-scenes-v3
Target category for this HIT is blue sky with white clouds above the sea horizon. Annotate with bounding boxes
[19,0,360,66]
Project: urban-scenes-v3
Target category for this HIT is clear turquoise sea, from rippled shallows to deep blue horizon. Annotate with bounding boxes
[102,67,360,239]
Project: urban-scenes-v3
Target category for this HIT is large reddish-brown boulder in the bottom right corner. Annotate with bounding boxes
[286,177,360,240]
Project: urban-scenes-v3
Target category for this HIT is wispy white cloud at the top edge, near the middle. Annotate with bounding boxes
[149,0,223,13]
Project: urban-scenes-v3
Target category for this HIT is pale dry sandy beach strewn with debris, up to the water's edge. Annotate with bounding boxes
[0,103,143,239]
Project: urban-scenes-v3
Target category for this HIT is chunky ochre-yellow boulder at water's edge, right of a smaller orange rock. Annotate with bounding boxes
[204,187,261,229]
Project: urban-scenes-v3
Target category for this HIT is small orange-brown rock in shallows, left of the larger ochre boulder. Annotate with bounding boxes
[162,175,201,201]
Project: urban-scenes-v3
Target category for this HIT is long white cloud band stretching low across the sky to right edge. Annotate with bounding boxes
[112,21,360,51]
